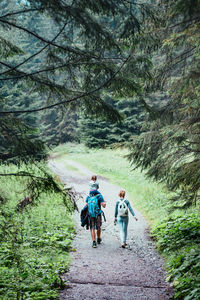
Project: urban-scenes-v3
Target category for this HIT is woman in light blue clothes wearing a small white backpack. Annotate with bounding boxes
[114,190,138,248]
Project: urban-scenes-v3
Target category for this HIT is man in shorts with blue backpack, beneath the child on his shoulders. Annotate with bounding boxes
[86,192,106,248]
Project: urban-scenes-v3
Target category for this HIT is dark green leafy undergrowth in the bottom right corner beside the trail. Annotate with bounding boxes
[152,213,200,300]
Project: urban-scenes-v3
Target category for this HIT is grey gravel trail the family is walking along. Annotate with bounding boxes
[50,160,173,300]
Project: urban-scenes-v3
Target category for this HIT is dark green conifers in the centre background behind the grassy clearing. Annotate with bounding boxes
[77,97,144,147]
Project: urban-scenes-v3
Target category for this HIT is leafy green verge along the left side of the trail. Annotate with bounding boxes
[0,165,74,300]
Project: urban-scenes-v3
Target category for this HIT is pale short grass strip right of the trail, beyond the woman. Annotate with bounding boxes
[55,144,173,222]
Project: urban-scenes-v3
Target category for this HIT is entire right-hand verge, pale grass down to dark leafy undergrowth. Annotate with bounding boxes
[55,144,200,300]
